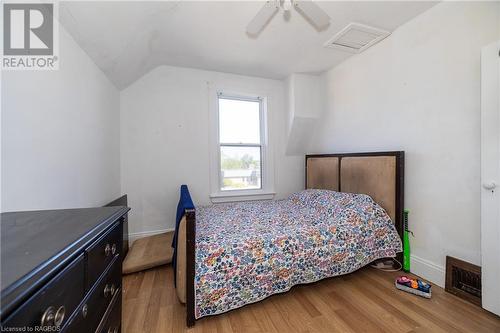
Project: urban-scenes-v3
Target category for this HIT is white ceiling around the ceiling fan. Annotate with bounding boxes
[60,1,435,89]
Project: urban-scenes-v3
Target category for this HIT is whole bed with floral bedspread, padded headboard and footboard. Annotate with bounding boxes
[174,151,404,326]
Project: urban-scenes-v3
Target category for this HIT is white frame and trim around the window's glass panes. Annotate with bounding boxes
[209,87,275,203]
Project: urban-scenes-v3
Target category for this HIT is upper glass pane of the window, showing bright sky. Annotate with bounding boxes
[219,98,260,143]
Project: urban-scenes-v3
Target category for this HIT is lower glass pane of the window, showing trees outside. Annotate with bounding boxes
[220,146,261,191]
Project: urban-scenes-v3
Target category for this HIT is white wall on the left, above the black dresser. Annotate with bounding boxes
[1,26,120,211]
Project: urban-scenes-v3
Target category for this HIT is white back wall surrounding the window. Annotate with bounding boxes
[120,66,304,238]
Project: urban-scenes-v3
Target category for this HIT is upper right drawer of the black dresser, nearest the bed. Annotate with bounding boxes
[86,222,123,290]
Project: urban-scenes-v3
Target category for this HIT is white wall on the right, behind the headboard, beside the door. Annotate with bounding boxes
[311,2,500,284]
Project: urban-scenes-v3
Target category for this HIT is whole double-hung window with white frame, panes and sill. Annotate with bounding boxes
[208,87,280,203]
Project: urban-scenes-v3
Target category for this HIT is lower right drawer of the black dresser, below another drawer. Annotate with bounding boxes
[64,257,122,333]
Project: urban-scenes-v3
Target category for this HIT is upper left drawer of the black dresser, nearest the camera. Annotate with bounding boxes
[2,254,85,329]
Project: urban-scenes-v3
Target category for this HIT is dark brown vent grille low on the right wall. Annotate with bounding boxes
[445,256,481,306]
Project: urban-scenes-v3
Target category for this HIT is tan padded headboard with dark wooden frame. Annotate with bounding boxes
[306,151,404,259]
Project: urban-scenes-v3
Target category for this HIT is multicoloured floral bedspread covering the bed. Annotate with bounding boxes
[195,190,401,318]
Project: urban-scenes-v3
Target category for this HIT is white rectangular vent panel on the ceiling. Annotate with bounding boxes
[324,23,391,53]
